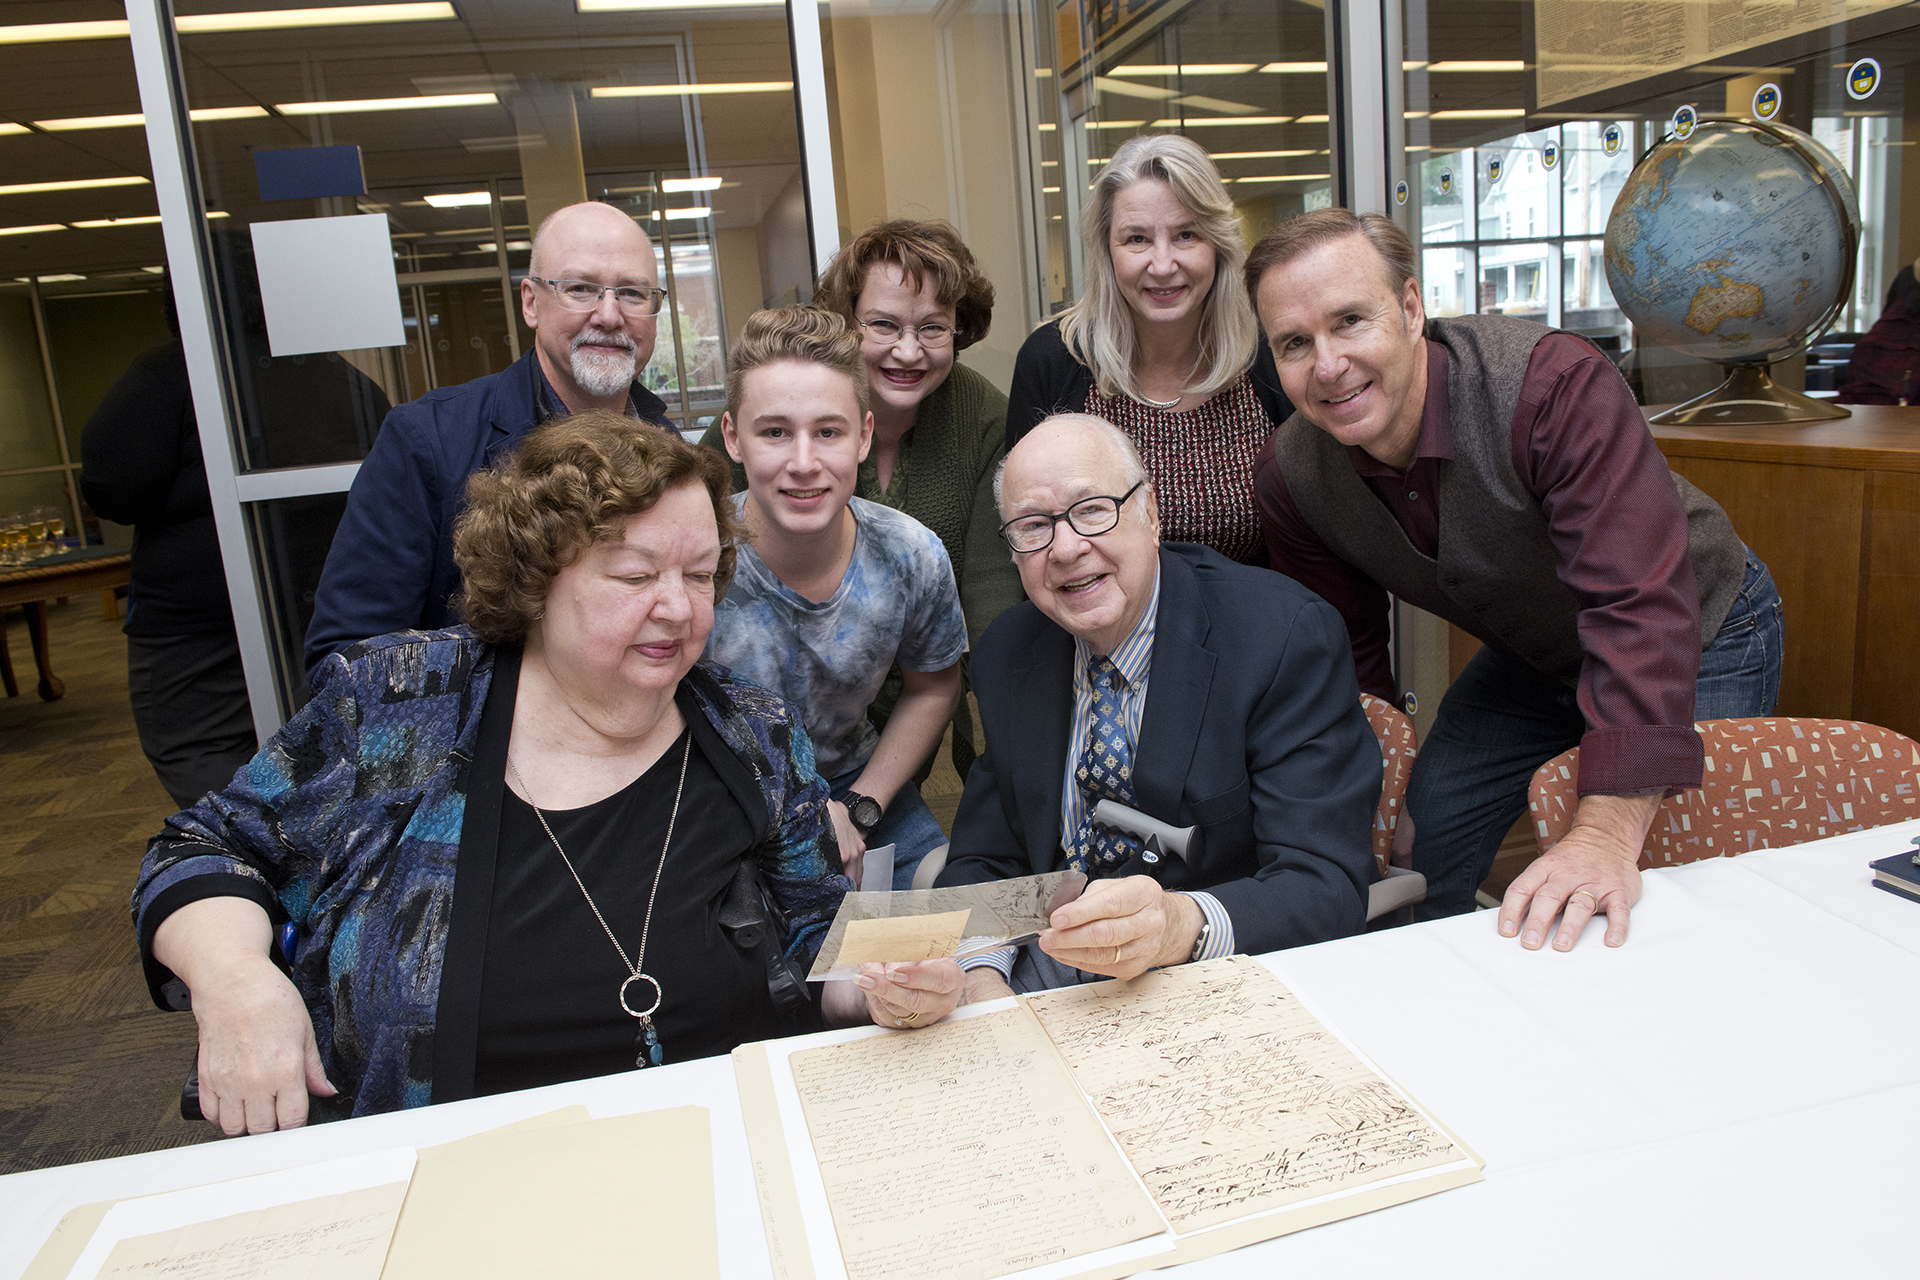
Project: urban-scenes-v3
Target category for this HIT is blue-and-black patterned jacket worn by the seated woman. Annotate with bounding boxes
[132,628,851,1117]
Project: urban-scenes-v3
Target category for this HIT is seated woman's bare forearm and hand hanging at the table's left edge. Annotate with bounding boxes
[154,898,338,1136]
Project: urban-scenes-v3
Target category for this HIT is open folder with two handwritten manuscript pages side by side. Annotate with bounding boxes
[733,956,1480,1280]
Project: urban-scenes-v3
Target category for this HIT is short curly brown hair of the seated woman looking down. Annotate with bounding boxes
[453,409,747,645]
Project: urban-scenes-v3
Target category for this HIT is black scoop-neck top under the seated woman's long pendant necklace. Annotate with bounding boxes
[474,695,785,1094]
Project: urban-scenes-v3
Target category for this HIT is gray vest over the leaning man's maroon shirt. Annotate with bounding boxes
[1273,315,1747,685]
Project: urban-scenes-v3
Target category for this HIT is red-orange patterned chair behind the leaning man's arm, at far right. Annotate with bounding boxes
[1528,716,1920,869]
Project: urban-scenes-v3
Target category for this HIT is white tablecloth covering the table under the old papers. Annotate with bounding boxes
[0,821,1920,1280]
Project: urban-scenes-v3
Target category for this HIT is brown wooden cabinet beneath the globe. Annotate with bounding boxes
[1647,405,1920,737]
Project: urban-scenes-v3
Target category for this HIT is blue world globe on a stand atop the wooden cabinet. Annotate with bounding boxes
[1607,115,1860,426]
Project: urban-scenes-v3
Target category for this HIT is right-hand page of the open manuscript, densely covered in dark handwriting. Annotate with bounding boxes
[1029,956,1463,1234]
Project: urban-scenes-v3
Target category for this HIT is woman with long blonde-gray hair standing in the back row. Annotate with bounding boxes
[1006,134,1294,564]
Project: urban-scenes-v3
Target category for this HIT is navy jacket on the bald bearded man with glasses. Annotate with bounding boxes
[307,349,666,672]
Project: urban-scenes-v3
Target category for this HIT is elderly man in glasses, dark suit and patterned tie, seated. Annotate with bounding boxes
[939,415,1380,1000]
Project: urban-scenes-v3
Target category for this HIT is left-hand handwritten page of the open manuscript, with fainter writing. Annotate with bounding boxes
[789,1007,1165,1280]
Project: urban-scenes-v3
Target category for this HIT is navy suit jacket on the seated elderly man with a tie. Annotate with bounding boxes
[939,543,1380,954]
